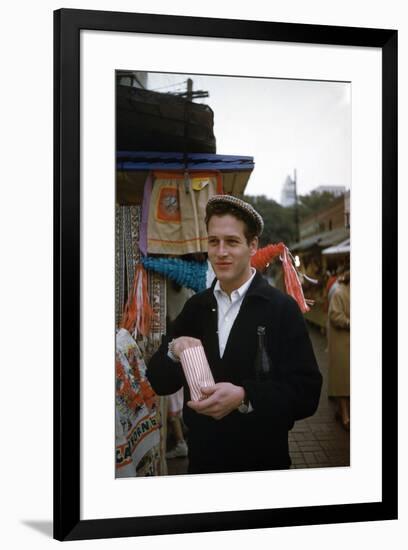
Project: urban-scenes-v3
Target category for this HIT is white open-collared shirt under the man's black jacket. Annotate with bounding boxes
[214,267,256,357]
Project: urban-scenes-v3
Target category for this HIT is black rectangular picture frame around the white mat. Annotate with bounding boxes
[54,9,397,540]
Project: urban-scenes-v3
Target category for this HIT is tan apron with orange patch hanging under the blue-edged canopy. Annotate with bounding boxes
[147,172,222,256]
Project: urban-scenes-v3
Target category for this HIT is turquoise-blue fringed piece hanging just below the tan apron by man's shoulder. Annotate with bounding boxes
[141,256,207,292]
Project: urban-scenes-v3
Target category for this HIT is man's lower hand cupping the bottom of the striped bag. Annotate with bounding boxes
[187,382,245,420]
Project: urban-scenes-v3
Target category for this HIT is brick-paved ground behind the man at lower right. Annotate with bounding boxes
[167,325,350,475]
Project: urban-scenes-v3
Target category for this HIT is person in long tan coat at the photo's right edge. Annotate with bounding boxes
[328,271,350,431]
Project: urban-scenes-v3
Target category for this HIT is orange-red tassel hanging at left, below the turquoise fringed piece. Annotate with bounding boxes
[120,264,153,336]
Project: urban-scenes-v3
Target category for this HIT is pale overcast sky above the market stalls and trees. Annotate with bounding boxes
[147,73,351,202]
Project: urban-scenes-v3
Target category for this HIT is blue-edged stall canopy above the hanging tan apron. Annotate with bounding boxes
[116,151,254,204]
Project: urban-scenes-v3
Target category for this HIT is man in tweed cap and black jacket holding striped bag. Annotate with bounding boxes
[147,195,322,473]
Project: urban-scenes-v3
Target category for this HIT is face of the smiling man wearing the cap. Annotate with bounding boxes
[208,214,258,293]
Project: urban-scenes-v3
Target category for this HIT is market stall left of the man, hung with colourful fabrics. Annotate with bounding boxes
[115,151,254,477]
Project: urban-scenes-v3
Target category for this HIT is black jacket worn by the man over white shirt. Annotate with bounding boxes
[147,273,322,473]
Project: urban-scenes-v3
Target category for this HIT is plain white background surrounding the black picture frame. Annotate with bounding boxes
[0,0,408,549]
